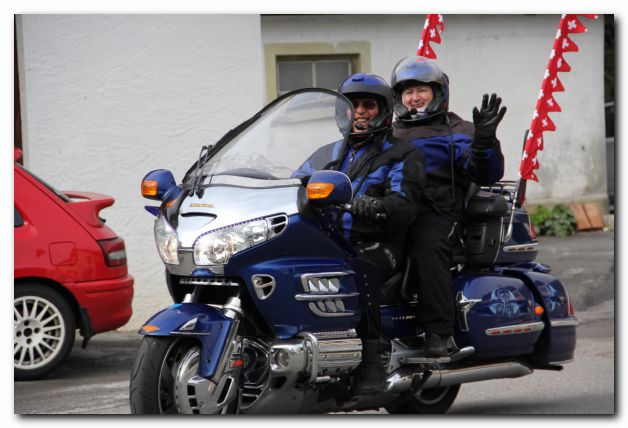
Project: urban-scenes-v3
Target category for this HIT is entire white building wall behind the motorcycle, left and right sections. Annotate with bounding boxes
[17,14,606,330]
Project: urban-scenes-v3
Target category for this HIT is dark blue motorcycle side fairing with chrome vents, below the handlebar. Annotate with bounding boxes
[225,215,370,339]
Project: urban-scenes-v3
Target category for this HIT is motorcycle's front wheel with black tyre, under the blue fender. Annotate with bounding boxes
[129,336,239,414]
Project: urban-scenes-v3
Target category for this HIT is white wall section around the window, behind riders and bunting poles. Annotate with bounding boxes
[262,14,606,203]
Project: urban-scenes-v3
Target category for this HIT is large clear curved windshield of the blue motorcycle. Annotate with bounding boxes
[189,89,354,186]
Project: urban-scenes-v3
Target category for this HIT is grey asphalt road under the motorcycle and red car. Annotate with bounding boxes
[13,232,616,419]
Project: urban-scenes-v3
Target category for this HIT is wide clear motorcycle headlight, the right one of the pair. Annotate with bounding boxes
[194,219,268,265]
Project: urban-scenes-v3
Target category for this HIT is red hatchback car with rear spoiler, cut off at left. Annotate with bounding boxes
[13,149,133,380]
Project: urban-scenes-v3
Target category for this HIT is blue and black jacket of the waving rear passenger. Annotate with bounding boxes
[393,112,504,215]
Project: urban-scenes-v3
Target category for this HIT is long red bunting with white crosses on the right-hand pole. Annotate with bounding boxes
[519,14,598,182]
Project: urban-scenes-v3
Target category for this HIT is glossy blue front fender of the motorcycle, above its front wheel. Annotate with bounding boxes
[139,303,237,379]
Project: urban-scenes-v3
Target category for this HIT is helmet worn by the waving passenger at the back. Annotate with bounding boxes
[390,56,449,124]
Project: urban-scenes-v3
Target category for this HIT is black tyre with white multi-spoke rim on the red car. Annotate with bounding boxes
[13,283,76,380]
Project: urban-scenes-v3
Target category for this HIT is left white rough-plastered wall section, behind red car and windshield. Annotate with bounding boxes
[18,15,264,329]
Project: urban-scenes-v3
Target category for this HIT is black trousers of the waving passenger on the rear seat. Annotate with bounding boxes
[410,212,459,336]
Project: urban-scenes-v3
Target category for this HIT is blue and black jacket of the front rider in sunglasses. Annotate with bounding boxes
[293,135,425,248]
